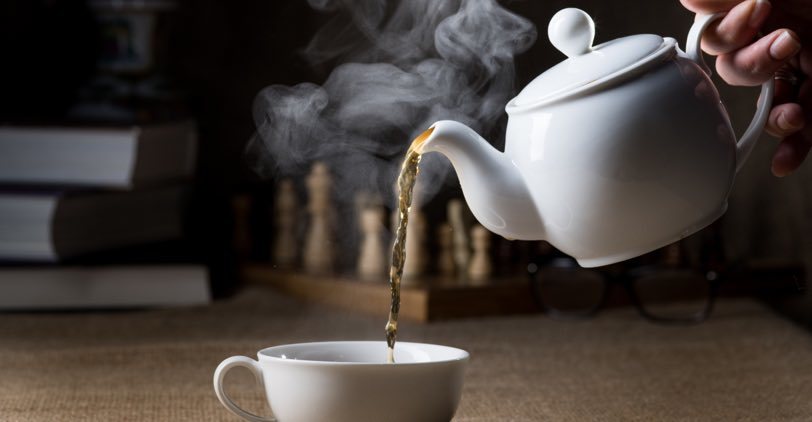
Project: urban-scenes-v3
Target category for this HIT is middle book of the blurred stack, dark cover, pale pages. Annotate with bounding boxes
[0,185,185,262]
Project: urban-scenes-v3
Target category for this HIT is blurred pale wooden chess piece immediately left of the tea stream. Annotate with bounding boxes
[358,206,387,281]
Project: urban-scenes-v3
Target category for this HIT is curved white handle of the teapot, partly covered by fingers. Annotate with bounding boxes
[685,13,775,172]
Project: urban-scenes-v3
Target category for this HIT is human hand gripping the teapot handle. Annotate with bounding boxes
[680,0,812,177]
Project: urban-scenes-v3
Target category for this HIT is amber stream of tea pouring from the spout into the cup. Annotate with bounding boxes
[386,128,434,363]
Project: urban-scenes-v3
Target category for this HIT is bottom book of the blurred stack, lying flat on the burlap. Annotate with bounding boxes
[0,264,211,311]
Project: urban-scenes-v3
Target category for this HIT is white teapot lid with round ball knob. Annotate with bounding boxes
[506,8,676,112]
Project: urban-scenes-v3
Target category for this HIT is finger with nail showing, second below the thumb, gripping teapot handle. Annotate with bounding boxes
[716,29,801,86]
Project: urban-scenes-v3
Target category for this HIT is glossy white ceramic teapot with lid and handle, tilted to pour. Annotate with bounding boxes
[421,8,773,267]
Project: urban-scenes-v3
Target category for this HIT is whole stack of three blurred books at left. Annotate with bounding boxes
[0,122,210,310]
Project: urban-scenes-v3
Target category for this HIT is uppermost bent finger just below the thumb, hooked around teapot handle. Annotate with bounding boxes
[702,0,771,56]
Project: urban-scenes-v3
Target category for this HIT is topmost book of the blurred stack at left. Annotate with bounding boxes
[0,122,197,189]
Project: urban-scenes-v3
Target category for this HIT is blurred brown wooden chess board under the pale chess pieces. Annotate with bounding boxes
[242,264,541,322]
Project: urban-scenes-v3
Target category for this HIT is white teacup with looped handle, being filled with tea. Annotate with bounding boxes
[214,341,469,422]
